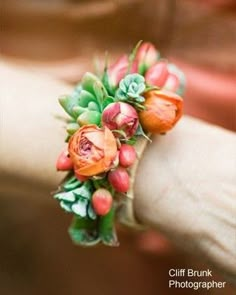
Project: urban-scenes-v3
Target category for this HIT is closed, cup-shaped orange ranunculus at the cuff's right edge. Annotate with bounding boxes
[139,90,183,133]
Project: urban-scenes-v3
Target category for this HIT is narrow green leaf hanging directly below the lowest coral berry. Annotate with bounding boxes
[99,208,119,246]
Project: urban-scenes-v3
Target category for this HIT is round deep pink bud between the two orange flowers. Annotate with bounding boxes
[102,102,138,139]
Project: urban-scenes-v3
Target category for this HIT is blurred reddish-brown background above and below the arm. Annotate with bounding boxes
[0,0,236,295]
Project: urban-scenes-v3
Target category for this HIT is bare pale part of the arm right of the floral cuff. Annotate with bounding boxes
[135,117,236,277]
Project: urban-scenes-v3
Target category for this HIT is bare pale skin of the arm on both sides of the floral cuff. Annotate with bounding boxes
[0,64,236,281]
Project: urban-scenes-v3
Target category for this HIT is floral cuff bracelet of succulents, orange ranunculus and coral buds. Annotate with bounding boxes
[54,42,185,246]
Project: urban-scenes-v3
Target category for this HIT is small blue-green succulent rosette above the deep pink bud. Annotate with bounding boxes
[115,74,146,103]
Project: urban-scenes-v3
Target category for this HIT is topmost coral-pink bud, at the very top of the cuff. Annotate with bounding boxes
[136,42,160,74]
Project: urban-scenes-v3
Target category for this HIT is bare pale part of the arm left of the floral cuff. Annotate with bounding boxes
[0,64,71,198]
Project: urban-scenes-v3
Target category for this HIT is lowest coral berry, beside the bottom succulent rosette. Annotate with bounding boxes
[92,188,112,216]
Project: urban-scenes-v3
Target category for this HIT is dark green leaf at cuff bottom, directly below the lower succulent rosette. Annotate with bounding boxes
[68,216,100,246]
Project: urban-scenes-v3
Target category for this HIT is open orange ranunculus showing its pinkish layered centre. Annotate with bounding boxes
[68,125,117,176]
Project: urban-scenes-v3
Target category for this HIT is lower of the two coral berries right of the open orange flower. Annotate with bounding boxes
[108,167,129,193]
